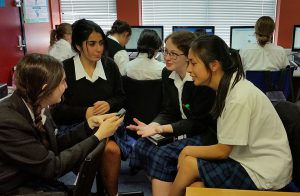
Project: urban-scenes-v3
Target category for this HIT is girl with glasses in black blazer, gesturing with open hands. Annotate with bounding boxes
[128,31,215,196]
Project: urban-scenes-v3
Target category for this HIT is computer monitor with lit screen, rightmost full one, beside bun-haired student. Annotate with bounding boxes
[230,26,256,50]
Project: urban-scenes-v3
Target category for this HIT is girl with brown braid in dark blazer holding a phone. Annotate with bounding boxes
[0,54,123,195]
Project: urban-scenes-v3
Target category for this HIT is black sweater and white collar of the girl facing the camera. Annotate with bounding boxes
[51,55,125,125]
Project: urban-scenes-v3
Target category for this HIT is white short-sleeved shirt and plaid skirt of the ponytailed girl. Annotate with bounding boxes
[198,74,292,190]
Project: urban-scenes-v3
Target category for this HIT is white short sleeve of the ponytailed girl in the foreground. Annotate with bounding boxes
[217,103,251,145]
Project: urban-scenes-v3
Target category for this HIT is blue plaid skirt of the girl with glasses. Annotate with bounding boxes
[129,136,201,182]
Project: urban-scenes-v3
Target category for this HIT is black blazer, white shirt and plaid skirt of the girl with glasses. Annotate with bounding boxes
[129,68,216,182]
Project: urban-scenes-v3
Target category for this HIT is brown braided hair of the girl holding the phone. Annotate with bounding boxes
[16,53,64,147]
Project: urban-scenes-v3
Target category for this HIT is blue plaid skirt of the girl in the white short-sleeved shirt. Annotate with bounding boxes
[197,158,257,190]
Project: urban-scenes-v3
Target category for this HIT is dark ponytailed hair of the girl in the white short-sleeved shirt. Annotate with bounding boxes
[191,35,245,118]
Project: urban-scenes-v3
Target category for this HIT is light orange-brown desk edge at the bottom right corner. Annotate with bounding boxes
[186,187,300,196]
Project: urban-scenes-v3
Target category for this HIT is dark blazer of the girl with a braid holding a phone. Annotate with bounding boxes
[0,92,99,195]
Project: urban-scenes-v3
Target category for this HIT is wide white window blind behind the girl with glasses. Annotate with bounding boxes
[142,0,276,44]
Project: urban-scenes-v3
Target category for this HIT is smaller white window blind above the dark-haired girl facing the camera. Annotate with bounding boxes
[60,0,117,32]
